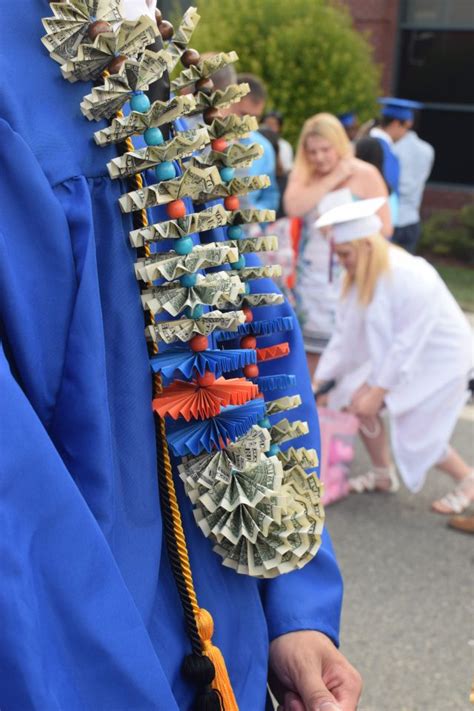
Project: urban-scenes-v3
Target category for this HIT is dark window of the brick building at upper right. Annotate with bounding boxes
[396,0,474,185]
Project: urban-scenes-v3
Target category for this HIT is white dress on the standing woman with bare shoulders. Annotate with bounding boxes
[295,188,353,353]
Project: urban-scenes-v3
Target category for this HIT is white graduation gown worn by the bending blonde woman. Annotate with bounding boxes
[316,247,473,491]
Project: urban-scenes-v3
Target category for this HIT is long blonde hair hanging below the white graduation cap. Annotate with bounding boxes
[342,234,390,306]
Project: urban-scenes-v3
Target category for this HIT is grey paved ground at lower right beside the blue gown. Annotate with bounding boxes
[327,407,474,711]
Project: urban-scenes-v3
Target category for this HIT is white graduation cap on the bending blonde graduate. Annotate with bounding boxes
[315,197,386,244]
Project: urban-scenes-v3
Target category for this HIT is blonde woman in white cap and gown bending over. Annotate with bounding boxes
[316,199,474,514]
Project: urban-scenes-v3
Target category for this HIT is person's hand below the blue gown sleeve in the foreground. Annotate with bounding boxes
[269,630,362,711]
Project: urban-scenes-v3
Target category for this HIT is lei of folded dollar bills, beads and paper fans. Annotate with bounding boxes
[43,0,324,578]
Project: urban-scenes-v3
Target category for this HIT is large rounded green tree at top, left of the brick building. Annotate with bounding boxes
[192,0,379,142]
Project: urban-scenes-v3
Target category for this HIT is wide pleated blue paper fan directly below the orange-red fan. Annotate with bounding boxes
[166,398,265,457]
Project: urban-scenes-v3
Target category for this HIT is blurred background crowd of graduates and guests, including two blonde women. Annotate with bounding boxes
[233,75,474,514]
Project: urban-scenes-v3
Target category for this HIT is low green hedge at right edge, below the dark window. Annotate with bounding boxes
[419,204,474,264]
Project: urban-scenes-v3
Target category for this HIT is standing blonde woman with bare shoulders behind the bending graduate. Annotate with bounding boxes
[283,113,392,376]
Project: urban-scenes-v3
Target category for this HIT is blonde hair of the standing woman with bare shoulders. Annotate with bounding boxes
[294,113,353,179]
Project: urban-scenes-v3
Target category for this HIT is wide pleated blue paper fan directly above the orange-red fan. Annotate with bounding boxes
[150,348,257,380]
